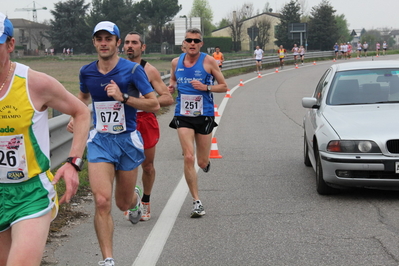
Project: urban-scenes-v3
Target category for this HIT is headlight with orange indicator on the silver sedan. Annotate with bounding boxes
[327,140,381,153]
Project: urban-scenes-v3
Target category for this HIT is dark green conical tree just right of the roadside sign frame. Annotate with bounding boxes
[308,0,338,50]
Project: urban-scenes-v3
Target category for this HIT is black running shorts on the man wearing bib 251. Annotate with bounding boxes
[169,116,218,135]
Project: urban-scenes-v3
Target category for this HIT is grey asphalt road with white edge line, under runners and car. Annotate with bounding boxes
[46,56,399,266]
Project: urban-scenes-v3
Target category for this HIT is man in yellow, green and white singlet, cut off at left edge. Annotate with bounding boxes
[0,13,90,266]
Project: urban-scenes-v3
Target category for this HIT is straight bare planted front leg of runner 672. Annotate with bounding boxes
[89,162,115,259]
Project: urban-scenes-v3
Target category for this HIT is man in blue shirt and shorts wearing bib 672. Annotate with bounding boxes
[69,21,159,266]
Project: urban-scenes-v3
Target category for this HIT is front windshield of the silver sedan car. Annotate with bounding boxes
[327,69,399,105]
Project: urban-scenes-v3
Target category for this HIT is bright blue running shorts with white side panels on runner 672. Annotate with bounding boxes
[87,129,145,171]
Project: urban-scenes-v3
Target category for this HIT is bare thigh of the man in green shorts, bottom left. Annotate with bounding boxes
[0,211,51,266]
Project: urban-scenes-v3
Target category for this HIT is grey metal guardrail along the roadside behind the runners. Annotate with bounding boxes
[49,51,334,170]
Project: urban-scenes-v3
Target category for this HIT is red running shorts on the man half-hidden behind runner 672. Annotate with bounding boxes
[137,112,160,149]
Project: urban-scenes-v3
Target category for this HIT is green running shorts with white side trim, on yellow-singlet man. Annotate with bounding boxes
[0,174,58,232]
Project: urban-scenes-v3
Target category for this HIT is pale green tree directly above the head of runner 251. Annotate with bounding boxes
[189,0,215,36]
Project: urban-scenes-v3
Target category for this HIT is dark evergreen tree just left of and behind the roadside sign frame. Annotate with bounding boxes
[274,0,301,47]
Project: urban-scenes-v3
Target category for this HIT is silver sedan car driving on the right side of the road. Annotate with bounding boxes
[302,61,399,195]
